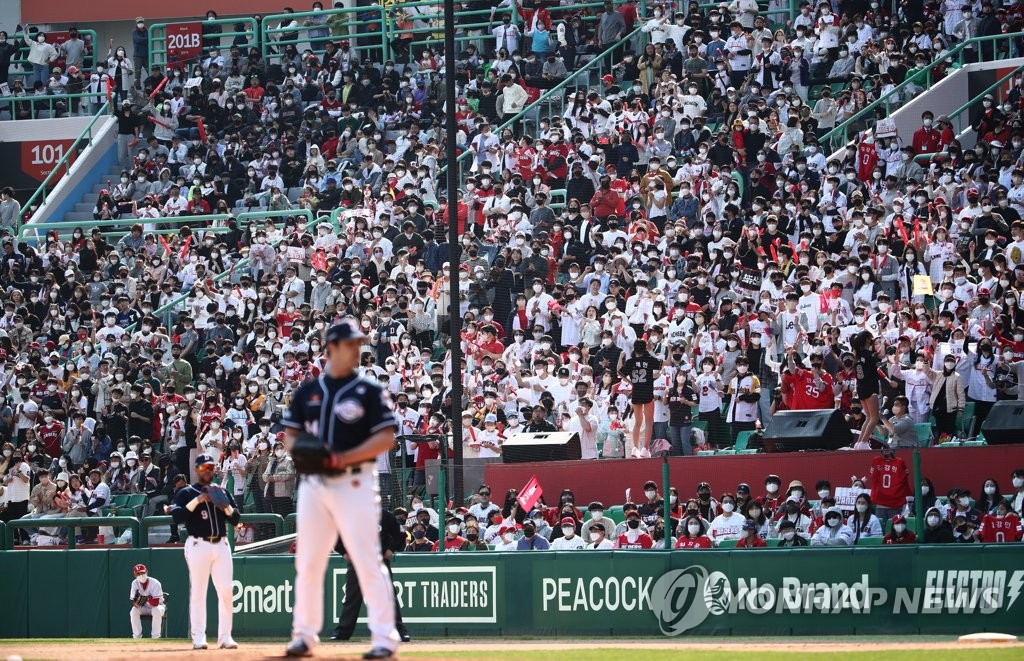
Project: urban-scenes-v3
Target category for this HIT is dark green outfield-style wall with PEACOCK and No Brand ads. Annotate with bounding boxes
[0,541,1024,642]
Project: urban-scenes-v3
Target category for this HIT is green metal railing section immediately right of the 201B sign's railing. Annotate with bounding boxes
[260,5,390,62]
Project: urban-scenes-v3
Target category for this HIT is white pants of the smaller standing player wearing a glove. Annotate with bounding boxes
[185,537,233,644]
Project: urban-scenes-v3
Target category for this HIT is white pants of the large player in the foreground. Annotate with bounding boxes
[292,470,399,650]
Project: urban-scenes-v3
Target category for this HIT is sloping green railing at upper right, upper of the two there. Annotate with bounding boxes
[818,32,1024,151]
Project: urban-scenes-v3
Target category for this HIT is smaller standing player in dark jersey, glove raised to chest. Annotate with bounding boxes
[171,454,242,650]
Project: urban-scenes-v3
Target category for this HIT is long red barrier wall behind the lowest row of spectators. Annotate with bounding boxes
[483,445,1024,506]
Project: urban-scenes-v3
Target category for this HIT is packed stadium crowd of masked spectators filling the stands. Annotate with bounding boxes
[0,0,1024,550]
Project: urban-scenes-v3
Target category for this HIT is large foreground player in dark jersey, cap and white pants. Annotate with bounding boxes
[282,318,399,659]
